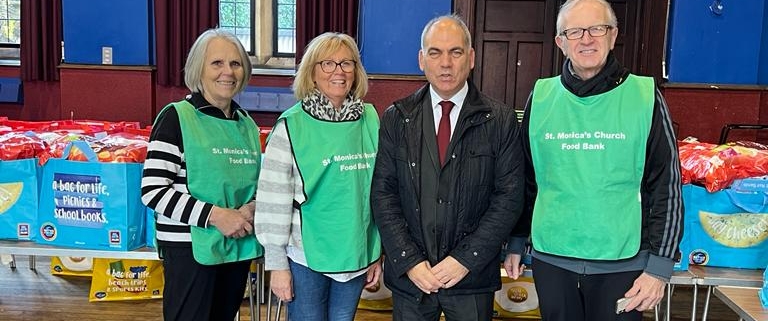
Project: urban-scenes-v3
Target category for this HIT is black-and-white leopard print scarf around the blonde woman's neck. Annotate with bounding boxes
[301,89,363,121]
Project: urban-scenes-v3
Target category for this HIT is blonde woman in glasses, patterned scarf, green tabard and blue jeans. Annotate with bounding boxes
[254,32,381,321]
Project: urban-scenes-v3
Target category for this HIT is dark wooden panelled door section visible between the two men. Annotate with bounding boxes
[460,0,557,109]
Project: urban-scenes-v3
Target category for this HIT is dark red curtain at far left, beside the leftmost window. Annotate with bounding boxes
[20,0,62,81]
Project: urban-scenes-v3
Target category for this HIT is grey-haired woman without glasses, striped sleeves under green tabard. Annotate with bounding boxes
[141,29,262,320]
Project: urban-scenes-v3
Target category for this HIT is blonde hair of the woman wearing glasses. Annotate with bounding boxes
[293,32,368,100]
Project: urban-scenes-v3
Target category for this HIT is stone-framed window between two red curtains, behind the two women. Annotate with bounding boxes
[219,0,296,69]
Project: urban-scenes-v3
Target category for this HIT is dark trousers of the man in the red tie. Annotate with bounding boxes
[392,292,493,321]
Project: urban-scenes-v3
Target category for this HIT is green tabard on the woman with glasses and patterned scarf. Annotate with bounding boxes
[278,102,381,273]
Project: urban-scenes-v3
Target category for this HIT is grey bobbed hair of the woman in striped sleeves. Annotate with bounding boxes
[184,28,251,93]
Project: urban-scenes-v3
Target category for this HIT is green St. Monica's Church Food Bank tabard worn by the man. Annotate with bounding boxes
[528,75,654,260]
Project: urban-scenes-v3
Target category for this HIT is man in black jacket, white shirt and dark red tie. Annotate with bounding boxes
[371,16,523,320]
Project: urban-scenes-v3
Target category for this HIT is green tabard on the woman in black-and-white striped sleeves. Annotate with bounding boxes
[166,101,263,265]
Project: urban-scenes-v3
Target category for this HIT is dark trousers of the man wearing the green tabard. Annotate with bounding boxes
[531,258,643,321]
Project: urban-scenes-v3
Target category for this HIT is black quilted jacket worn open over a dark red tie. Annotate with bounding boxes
[371,83,524,298]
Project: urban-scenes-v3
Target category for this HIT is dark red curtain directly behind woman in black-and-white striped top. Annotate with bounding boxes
[154,0,219,87]
